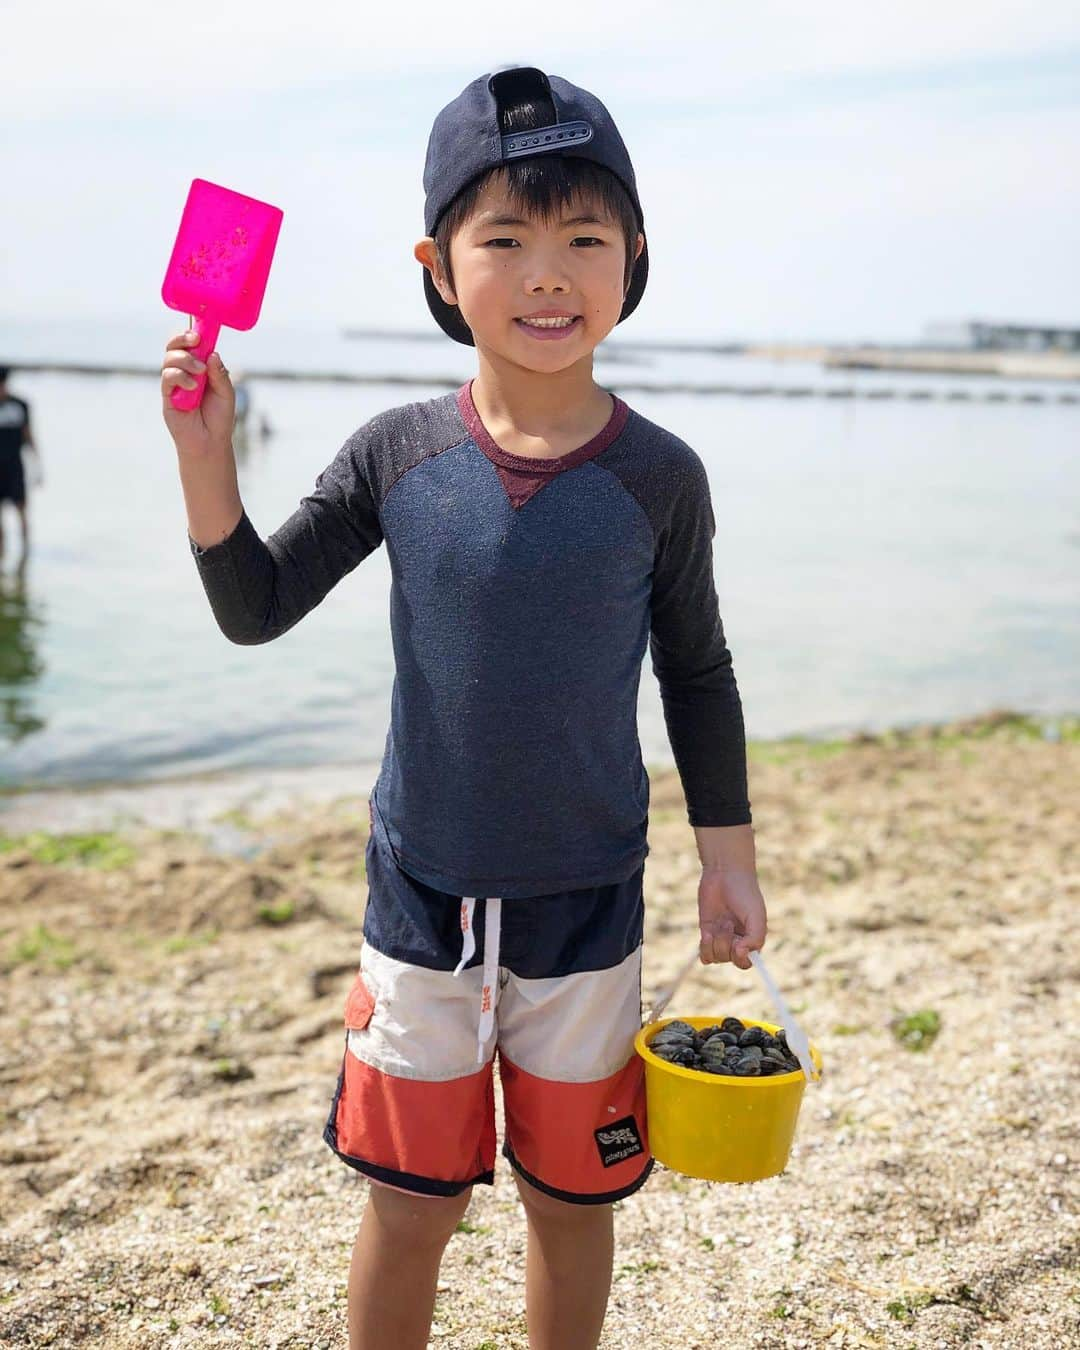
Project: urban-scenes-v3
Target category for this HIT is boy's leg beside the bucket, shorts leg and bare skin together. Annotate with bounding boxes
[498,867,652,1350]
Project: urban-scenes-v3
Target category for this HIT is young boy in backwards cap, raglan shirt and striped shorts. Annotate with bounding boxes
[162,66,765,1350]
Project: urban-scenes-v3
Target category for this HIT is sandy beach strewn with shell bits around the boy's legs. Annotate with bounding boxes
[0,713,1080,1350]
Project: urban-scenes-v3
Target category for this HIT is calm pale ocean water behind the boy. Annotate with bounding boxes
[0,313,1080,787]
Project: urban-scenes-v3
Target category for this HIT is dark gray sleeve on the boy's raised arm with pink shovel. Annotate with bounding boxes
[188,420,382,647]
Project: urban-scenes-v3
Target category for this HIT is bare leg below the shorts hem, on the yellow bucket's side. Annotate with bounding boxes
[514,1173,614,1350]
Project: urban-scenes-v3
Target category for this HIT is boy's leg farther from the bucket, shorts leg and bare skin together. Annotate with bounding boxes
[323,801,495,1350]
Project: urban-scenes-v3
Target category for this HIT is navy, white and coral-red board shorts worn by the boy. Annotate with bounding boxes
[323,794,653,1204]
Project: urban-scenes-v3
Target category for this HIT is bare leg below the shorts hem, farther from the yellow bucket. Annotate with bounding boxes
[348,1183,473,1350]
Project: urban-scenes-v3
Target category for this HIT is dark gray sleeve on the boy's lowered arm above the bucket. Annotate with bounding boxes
[649,455,751,825]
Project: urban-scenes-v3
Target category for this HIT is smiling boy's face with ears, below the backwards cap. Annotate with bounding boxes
[414,171,644,373]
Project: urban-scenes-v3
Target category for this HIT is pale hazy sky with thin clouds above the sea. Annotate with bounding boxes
[0,0,1080,342]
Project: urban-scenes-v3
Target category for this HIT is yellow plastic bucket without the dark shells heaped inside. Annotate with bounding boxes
[633,1017,821,1181]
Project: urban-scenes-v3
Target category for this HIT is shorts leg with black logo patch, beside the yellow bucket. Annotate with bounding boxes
[497,867,652,1204]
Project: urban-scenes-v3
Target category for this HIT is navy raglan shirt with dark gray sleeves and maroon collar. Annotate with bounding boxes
[188,381,751,898]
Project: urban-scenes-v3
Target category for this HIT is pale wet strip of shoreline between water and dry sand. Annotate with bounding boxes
[0,707,1080,838]
